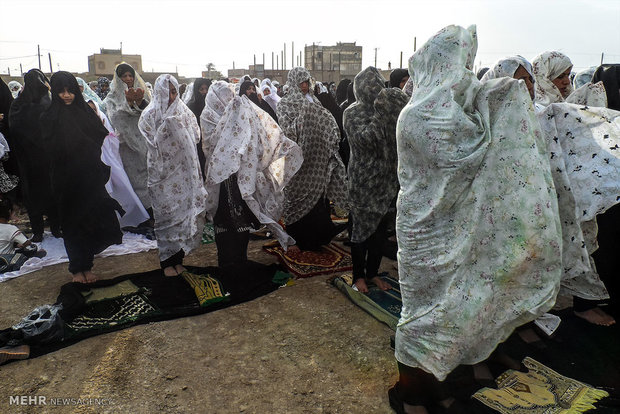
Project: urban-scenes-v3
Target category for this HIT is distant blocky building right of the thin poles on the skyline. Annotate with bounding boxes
[304,42,362,82]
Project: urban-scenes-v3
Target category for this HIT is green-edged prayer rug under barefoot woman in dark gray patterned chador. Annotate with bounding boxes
[332,272,403,330]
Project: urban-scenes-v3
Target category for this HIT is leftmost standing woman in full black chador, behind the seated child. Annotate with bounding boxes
[9,69,60,242]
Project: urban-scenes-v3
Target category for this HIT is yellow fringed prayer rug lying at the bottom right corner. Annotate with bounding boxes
[474,357,609,414]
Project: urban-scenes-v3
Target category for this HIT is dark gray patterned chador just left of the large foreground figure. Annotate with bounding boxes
[344,67,408,243]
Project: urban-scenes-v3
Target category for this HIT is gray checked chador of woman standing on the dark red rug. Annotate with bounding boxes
[277,67,347,225]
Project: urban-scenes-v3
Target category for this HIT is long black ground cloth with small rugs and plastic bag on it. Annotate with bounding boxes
[0,260,290,363]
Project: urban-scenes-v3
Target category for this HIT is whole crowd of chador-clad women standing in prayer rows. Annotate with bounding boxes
[0,26,620,413]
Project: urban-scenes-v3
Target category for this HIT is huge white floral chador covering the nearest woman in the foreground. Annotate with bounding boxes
[396,26,562,380]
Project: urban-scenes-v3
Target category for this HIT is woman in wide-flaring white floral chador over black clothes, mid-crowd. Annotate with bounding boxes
[200,81,303,266]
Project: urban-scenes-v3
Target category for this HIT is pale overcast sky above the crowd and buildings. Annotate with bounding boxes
[0,0,620,77]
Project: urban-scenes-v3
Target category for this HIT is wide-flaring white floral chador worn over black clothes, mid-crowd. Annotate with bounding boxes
[200,81,303,249]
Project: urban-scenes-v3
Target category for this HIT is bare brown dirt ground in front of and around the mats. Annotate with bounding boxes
[0,236,397,413]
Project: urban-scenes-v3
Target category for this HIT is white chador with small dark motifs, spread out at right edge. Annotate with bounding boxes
[537,103,620,300]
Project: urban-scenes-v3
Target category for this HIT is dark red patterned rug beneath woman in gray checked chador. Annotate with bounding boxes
[263,240,353,278]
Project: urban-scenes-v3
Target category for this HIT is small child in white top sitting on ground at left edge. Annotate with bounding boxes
[0,199,47,273]
